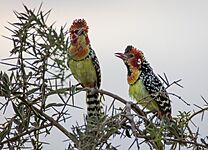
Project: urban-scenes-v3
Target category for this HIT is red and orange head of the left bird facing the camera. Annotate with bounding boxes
[69,19,90,60]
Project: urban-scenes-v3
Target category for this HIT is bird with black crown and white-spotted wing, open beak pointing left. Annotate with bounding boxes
[115,46,172,120]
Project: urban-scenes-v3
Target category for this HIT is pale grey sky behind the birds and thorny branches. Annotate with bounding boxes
[0,0,208,149]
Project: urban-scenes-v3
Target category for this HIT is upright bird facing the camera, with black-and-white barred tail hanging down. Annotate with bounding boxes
[68,19,102,117]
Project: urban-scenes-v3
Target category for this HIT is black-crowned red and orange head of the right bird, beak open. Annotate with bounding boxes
[115,45,145,84]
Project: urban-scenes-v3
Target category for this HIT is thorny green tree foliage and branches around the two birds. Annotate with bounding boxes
[0,5,208,150]
